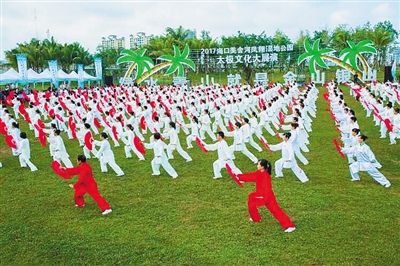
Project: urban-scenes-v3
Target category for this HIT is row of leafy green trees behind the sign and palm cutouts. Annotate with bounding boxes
[2,21,399,84]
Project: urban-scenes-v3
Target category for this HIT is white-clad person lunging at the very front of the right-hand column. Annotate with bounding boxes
[342,135,391,188]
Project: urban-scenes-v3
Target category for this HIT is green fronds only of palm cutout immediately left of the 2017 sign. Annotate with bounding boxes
[158,44,196,77]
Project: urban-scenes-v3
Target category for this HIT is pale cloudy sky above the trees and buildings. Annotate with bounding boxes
[0,0,400,59]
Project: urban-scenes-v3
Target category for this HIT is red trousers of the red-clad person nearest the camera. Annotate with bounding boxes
[247,193,295,229]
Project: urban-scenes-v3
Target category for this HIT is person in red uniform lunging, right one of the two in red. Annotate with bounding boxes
[237,159,296,233]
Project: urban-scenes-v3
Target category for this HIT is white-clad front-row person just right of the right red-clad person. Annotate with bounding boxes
[269,132,309,183]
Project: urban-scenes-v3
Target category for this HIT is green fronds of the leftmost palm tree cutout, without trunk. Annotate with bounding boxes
[117,48,154,80]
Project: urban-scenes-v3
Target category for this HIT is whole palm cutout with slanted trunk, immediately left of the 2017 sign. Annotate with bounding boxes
[137,44,196,84]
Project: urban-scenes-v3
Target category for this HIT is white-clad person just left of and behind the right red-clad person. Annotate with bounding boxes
[204,131,242,179]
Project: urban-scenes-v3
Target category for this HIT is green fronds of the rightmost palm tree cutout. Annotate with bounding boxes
[339,40,376,71]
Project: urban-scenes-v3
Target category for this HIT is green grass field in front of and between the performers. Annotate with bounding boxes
[0,86,400,265]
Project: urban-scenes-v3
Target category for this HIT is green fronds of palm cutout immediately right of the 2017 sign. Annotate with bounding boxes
[297,38,335,74]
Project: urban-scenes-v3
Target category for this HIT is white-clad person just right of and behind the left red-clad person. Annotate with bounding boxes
[93,132,125,176]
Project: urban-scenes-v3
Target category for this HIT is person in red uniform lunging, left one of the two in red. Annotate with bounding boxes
[64,155,112,215]
